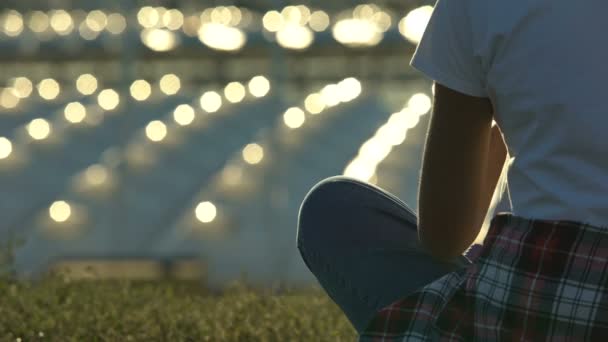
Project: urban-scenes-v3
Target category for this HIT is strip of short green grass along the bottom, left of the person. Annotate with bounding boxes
[0,276,356,341]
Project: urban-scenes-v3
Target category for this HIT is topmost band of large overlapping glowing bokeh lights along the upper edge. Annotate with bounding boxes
[0,4,433,51]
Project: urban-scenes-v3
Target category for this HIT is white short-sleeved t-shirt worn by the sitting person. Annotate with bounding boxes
[411,0,608,227]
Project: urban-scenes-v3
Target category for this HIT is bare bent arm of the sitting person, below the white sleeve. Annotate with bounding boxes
[418,84,506,260]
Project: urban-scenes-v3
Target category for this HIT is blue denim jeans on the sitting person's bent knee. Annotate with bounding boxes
[297,176,470,333]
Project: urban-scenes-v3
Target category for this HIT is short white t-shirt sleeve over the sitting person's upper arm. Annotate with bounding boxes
[410,0,488,97]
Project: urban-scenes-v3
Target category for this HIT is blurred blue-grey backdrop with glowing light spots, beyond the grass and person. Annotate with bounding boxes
[0,0,434,286]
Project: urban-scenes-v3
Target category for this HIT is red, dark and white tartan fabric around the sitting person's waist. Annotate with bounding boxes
[360,213,608,341]
